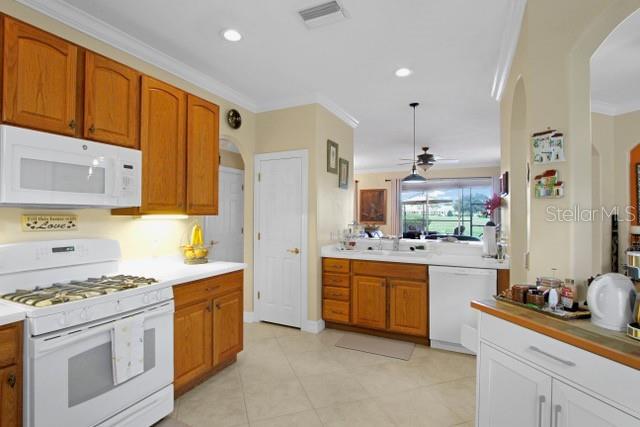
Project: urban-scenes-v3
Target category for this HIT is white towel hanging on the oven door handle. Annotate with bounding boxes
[111,314,144,385]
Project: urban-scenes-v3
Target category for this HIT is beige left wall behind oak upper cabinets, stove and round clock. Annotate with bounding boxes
[0,0,256,308]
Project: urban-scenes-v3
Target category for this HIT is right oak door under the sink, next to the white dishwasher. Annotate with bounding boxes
[389,279,427,337]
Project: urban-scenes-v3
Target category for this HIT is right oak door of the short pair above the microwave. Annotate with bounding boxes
[83,52,140,148]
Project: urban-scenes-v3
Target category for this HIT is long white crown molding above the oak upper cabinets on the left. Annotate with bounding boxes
[17,0,257,112]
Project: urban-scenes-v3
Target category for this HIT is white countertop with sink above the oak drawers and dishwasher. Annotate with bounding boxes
[321,245,509,270]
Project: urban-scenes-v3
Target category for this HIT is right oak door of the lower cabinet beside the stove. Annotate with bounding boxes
[213,292,243,366]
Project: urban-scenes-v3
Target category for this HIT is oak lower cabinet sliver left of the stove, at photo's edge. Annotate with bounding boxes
[0,322,23,427]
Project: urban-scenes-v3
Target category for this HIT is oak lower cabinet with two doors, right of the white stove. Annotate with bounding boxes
[174,271,243,398]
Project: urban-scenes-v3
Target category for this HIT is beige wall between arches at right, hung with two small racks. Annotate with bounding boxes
[501,0,640,288]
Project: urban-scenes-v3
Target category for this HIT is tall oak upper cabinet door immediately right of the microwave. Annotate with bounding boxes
[140,76,187,213]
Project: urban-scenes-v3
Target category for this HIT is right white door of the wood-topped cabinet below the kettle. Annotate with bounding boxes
[551,379,640,427]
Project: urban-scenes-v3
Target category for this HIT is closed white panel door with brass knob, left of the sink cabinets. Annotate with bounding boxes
[254,153,307,327]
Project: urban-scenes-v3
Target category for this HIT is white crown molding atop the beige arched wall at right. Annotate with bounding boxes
[491,0,527,102]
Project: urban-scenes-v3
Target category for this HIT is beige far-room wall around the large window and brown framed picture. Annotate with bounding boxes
[355,166,500,234]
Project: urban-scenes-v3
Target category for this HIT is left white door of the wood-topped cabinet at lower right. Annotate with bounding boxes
[477,343,551,427]
